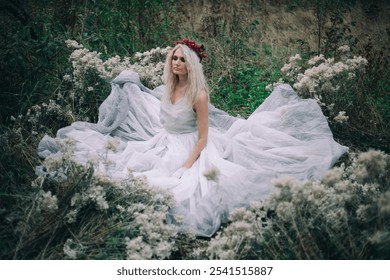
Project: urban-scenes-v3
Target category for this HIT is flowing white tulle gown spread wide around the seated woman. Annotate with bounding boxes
[38,71,347,236]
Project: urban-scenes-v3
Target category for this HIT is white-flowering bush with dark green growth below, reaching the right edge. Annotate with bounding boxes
[268,46,390,151]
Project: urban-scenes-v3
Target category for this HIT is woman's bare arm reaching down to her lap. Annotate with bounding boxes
[183,90,209,168]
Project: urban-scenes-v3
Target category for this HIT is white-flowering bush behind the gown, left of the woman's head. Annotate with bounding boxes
[11,40,171,135]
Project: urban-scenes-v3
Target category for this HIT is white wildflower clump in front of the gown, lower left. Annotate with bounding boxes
[17,139,189,259]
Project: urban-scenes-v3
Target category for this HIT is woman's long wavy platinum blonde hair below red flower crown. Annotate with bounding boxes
[162,44,209,107]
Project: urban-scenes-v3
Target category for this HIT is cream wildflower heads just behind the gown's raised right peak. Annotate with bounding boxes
[267,46,368,123]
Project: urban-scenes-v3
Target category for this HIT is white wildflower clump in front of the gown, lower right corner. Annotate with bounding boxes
[198,150,390,259]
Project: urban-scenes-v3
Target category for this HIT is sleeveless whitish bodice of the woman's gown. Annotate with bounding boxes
[160,97,197,134]
